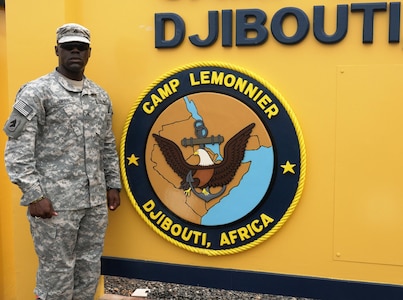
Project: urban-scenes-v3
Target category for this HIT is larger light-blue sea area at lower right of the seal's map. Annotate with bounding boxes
[201,147,274,226]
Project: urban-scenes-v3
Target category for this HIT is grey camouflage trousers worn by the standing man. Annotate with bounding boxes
[28,205,108,300]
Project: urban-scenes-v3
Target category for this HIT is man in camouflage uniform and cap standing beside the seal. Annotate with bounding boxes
[4,23,121,300]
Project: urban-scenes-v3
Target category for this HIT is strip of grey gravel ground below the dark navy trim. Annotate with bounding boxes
[104,276,312,300]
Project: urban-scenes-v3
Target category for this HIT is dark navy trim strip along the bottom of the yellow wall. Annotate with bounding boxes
[102,257,403,300]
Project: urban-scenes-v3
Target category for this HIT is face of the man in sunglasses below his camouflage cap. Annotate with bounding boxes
[55,42,91,73]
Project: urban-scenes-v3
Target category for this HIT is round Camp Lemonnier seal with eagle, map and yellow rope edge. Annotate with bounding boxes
[120,62,306,255]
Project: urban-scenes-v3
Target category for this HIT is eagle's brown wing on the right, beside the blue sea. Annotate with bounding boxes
[208,123,255,187]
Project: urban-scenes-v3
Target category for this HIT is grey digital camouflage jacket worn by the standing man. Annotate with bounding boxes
[4,71,121,211]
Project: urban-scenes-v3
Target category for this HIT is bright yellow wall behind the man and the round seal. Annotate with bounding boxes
[0,0,403,299]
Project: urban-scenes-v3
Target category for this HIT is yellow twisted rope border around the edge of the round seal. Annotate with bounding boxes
[120,61,306,256]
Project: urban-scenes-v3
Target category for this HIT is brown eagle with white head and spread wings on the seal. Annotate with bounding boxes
[153,123,255,202]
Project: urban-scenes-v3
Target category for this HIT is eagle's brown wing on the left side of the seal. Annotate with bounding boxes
[153,133,197,179]
